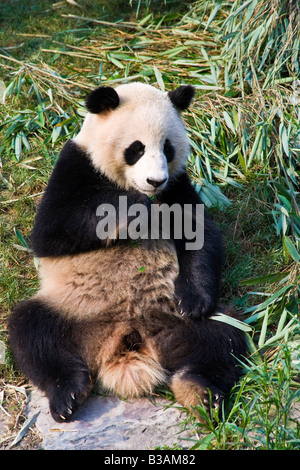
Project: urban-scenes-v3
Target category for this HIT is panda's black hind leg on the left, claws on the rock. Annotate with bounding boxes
[8,299,93,422]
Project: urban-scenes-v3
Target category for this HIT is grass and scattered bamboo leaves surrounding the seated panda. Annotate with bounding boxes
[0,0,300,449]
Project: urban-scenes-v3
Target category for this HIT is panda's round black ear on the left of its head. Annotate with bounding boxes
[85,86,120,114]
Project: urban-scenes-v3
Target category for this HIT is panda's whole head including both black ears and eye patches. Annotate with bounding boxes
[74,83,194,195]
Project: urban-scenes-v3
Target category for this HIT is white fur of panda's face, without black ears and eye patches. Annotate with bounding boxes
[74,83,190,195]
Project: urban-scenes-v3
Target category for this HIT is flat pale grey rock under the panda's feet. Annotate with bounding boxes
[26,390,192,450]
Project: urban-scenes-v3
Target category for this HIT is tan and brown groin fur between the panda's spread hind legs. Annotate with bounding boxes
[77,321,166,397]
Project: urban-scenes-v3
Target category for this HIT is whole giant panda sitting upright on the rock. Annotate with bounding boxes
[8,83,246,421]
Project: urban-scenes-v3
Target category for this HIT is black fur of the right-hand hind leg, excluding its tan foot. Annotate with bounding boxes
[156,305,246,394]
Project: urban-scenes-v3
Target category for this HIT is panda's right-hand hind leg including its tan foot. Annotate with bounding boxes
[157,307,247,420]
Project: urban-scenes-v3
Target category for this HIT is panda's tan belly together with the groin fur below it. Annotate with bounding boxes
[36,240,181,397]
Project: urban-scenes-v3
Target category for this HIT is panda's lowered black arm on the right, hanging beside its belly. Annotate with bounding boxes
[160,173,224,318]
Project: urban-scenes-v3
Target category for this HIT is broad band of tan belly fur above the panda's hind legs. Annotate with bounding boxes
[36,240,178,322]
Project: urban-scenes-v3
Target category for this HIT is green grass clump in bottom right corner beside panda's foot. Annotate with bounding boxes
[188,339,300,450]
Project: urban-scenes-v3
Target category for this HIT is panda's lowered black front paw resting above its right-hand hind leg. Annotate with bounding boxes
[175,278,216,320]
